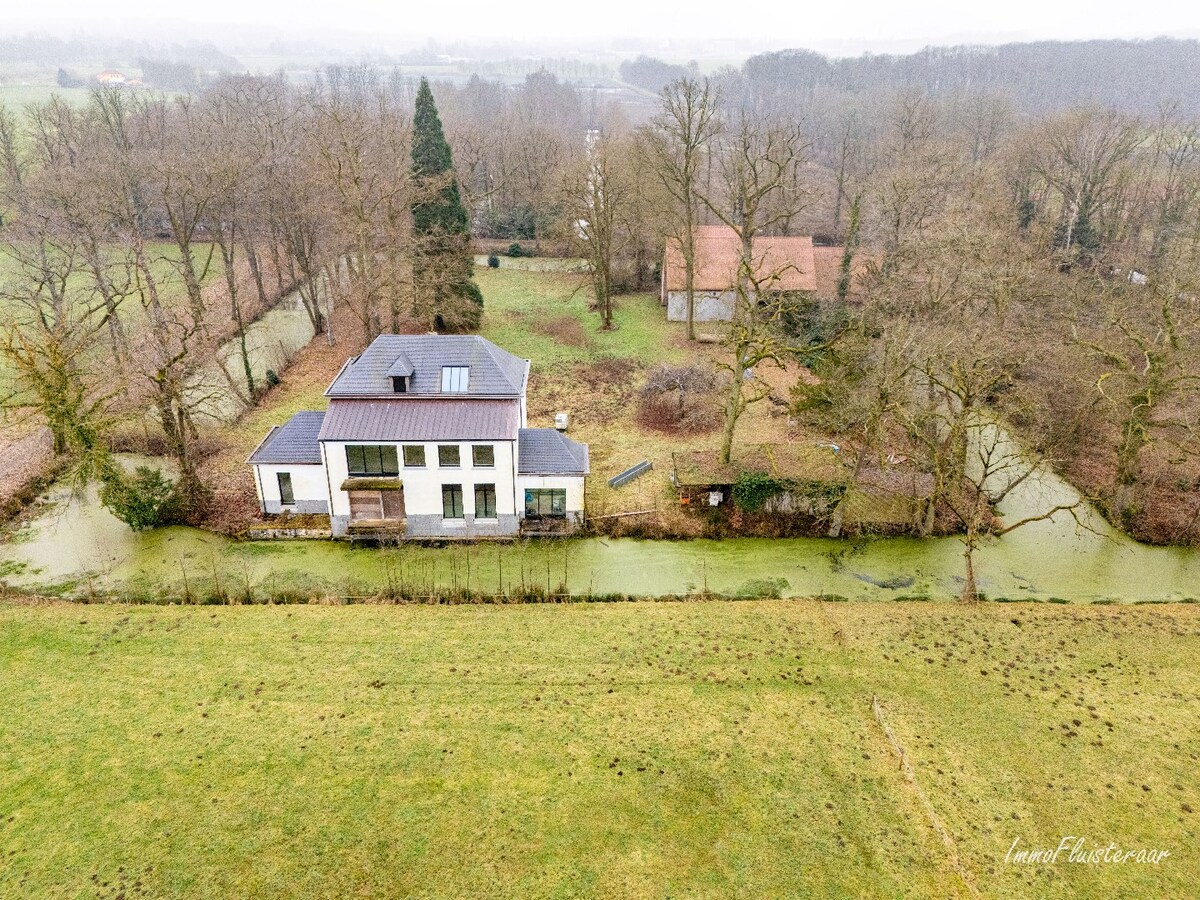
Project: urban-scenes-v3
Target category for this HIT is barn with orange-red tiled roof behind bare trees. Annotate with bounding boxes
[660,226,863,322]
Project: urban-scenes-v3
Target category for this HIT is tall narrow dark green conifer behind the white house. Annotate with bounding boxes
[413,78,484,331]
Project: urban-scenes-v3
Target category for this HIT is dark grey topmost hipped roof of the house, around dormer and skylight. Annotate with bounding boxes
[325,335,529,397]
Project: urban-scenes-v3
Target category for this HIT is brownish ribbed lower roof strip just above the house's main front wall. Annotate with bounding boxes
[320,395,521,440]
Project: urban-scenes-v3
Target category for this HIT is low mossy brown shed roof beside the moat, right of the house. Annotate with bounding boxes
[672,444,850,487]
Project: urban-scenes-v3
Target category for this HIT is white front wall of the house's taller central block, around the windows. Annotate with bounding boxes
[322,440,523,516]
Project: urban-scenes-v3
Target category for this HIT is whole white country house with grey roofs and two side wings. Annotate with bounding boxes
[248,335,588,539]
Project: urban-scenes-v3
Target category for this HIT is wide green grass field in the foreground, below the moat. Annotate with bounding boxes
[0,601,1200,898]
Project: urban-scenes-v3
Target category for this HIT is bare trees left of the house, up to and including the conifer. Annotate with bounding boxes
[0,70,481,518]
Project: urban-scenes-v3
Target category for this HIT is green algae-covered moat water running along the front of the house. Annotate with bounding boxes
[0,441,1200,602]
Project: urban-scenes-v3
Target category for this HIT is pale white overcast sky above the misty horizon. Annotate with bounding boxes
[9,0,1200,53]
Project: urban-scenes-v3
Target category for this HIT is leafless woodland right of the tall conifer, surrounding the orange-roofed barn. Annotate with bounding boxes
[443,63,1200,554]
